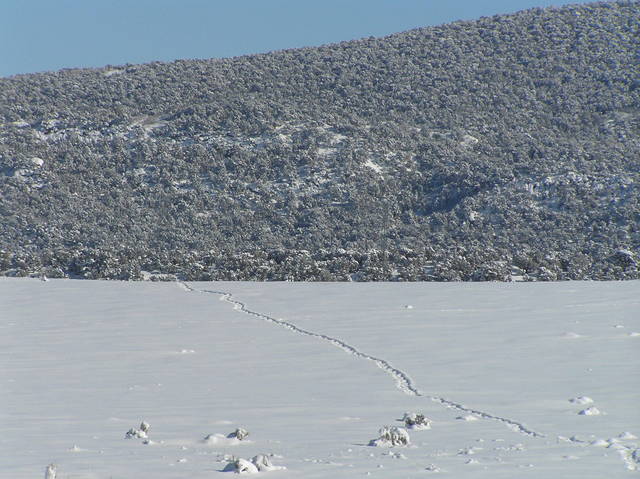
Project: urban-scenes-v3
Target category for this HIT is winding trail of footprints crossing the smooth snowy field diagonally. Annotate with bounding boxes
[178,282,545,438]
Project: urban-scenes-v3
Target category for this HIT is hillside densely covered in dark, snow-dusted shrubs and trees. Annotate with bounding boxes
[0,1,640,280]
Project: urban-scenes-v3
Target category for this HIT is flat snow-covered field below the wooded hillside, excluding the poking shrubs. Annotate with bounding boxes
[0,278,640,479]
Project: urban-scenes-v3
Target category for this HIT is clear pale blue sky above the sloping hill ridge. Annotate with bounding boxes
[0,0,587,76]
